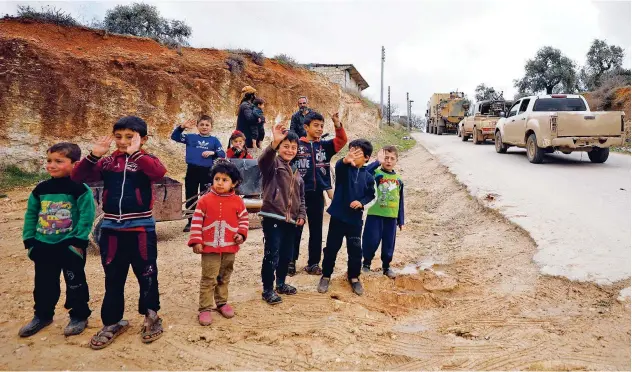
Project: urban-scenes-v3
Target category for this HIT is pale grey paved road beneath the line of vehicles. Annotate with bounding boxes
[414,133,631,284]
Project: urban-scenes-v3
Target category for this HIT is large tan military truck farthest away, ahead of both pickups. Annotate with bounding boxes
[426,92,470,135]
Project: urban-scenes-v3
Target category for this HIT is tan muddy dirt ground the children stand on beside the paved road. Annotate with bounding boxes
[0,141,630,370]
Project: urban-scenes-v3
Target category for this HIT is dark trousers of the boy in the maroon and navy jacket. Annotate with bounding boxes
[99,229,160,326]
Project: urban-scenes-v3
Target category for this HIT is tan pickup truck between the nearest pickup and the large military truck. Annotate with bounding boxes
[457,99,511,145]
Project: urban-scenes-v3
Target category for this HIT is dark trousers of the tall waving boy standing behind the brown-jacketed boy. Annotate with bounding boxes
[292,191,325,266]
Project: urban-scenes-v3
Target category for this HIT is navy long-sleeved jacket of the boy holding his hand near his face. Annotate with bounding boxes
[327,160,375,226]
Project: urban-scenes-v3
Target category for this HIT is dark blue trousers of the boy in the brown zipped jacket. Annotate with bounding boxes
[261,217,298,291]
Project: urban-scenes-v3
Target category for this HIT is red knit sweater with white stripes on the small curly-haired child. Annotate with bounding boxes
[189,189,248,253]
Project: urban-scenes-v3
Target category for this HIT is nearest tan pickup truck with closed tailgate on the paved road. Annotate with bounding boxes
[495,94,625,163]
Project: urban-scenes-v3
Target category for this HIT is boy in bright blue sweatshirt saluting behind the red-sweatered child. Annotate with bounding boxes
[171,115,226,232]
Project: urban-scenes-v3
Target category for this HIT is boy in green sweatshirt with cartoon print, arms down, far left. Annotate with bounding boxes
[19,142,95,337]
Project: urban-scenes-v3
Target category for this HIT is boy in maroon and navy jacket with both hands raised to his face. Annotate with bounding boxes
[72,116,167,349]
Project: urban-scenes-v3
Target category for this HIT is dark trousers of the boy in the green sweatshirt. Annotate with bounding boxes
[28,242,92,320]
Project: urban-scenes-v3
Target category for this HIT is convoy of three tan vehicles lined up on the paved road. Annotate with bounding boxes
[426,92,625,164]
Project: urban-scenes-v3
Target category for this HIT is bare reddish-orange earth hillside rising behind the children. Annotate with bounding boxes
[0,19,379,174]
